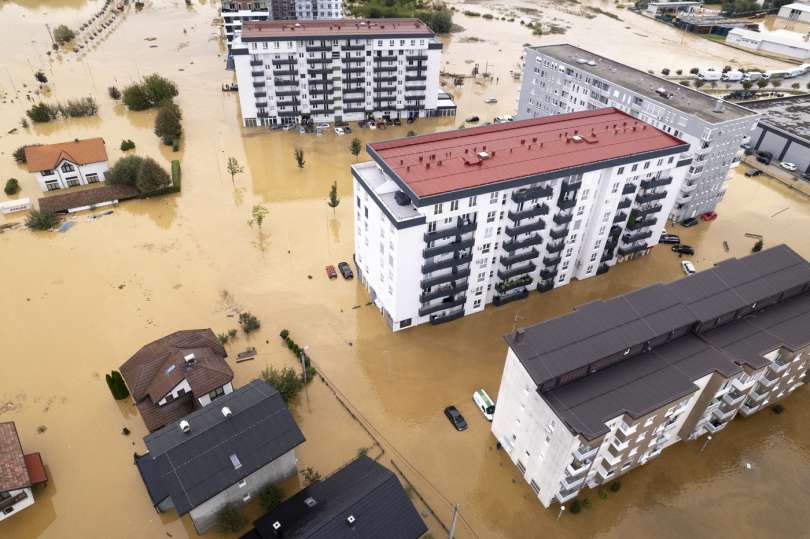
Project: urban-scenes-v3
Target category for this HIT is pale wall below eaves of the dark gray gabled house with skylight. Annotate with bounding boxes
[189,449,298,533]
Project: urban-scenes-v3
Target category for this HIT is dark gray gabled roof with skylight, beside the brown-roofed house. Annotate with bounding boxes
[136,380,304,515]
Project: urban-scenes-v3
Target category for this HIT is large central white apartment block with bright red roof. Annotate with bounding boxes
[352,109,690,330]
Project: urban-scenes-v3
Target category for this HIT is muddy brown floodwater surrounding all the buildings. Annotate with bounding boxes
[0,0,810,539]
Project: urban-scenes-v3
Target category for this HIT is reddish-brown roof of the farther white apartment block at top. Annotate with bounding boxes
[242,19,434,41]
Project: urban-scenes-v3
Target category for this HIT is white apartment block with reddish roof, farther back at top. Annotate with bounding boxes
[232,19,448,127]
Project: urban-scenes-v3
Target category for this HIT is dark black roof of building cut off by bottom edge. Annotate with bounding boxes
[241,455,428,539]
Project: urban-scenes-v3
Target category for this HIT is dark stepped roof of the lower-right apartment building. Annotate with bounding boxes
[506,245,810,438]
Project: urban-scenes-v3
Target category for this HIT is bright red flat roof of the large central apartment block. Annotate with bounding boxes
[369,108,687,197]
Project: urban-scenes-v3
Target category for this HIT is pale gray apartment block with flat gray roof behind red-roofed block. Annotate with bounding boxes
[517,45,759,221]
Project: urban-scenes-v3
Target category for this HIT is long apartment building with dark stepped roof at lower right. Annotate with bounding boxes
[492,245,810,507]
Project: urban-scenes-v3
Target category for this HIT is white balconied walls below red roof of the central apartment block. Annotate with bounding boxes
[352,143,688,331]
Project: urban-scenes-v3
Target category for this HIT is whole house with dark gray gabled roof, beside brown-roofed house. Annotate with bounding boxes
[135,380,304,533]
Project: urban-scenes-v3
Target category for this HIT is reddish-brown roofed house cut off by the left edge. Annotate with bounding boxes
[0,422,48,521]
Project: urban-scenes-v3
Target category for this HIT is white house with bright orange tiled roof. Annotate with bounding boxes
[25,138,109,191]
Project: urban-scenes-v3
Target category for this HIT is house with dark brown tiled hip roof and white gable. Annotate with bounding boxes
[120,329,233,432]
